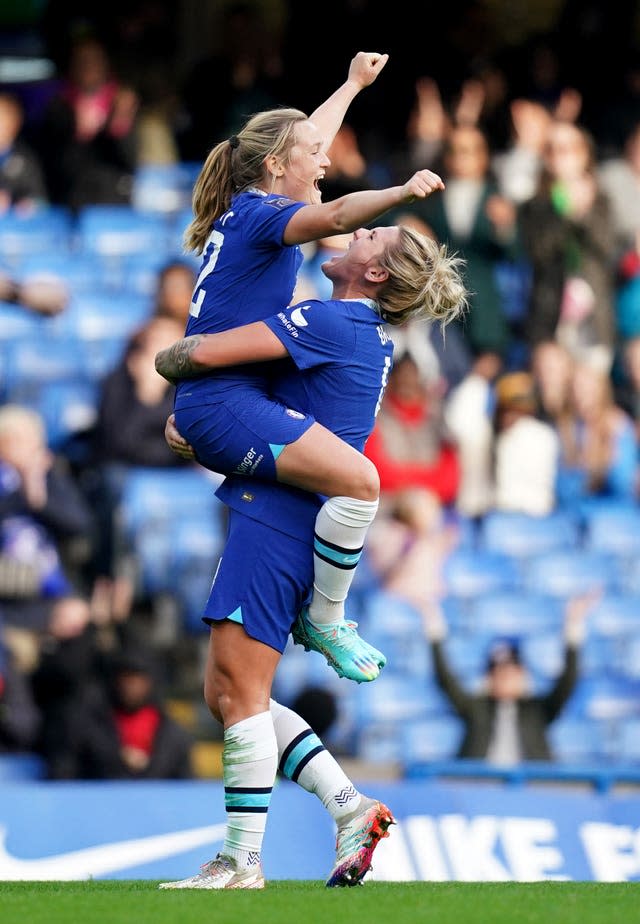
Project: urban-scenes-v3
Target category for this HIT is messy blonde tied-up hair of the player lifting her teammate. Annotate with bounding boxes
[376,226,468,327]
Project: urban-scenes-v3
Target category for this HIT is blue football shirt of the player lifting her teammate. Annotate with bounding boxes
[217,300,393,544]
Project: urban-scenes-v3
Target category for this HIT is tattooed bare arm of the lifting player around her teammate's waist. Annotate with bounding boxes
[155,321,288,383]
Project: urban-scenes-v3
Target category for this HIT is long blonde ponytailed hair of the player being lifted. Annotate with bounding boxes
[184,109,308,254]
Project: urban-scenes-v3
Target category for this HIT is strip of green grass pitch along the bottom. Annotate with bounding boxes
[0,880,640,924]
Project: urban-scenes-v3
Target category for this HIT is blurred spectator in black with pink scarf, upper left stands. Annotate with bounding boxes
[39,36,139,209]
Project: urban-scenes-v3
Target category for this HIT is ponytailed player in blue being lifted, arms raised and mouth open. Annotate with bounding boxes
[164,52,443,681]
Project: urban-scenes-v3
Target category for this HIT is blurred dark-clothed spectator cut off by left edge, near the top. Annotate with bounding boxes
[0,93,48,214]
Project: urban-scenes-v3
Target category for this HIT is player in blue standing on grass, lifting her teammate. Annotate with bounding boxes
[158,227,466,889]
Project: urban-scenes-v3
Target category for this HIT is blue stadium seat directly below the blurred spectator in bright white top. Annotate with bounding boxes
[478,510,580,558]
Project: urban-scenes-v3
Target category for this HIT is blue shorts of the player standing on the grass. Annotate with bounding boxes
[202,509,313,652]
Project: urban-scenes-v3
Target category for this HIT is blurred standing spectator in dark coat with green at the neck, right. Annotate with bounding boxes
[520,121,615,372]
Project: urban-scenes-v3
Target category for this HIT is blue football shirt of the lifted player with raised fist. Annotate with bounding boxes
[175,190,305,408]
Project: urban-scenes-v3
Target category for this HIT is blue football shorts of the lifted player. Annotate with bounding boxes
[175,394,315,481]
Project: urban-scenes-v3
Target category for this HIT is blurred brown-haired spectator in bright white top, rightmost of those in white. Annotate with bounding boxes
[494,372,560,516]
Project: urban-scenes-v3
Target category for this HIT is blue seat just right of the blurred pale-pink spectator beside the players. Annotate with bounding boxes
[443,548,520,600]
